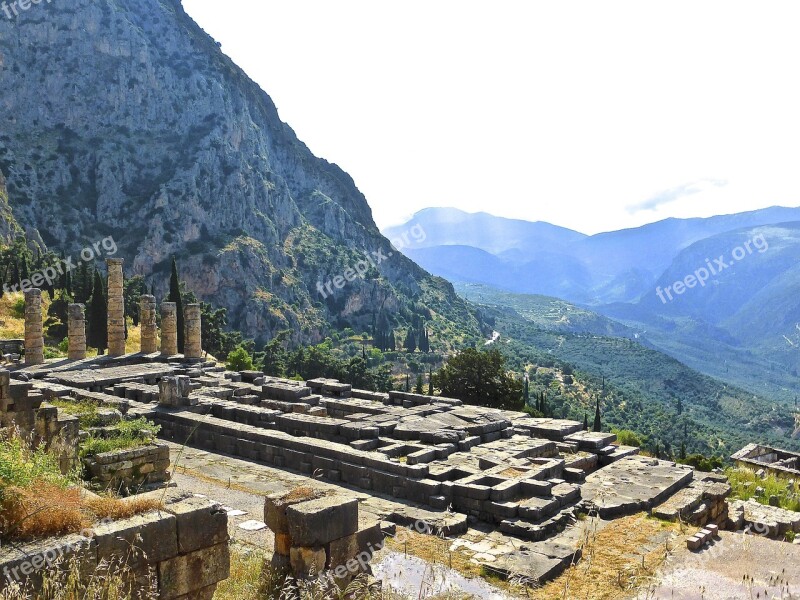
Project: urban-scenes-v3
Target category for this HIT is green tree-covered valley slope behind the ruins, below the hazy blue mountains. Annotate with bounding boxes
[489,309,798,458]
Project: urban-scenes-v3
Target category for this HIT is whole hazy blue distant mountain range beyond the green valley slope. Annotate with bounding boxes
[384,207,800,400]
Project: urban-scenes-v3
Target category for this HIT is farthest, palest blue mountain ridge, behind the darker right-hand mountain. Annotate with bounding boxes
[392,207,800,305]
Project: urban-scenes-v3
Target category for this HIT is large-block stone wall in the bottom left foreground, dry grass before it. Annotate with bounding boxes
[0,491,230,600]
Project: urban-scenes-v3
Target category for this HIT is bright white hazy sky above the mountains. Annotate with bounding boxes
[183,0,800,233]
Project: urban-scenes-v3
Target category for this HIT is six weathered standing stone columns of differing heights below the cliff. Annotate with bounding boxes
[25,259,203,365]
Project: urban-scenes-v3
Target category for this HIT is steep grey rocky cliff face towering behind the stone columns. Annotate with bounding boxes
[0,0,479,341]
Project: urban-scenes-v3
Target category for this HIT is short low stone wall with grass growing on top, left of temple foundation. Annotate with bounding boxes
[83,444,170,491]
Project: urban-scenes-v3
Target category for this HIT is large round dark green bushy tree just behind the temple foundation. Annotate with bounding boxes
[434,348,522,410]
